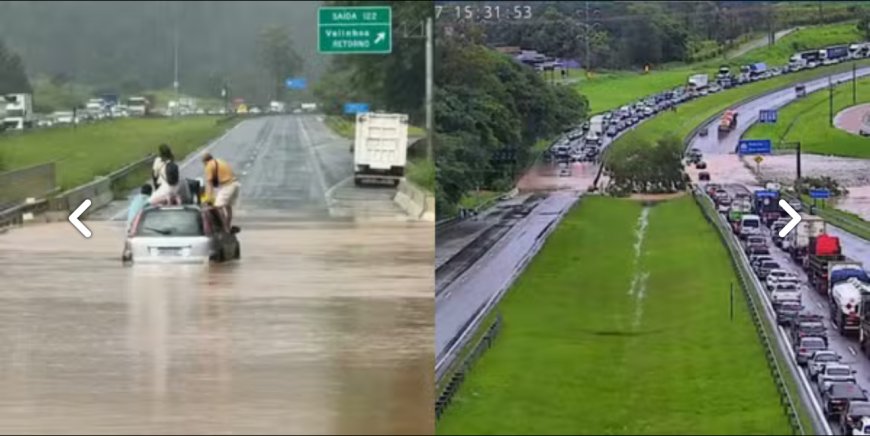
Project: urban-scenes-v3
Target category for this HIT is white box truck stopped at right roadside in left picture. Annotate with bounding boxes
[353,112,408,186]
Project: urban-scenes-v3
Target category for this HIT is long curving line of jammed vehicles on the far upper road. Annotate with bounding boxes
[543,42,870,174]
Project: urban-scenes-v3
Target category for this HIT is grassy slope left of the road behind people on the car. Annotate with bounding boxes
[0,117,235,189]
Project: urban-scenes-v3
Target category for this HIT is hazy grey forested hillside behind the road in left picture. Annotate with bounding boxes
[0,1,327,104]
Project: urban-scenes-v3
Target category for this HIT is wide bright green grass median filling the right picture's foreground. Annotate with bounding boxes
[437,197,789,434]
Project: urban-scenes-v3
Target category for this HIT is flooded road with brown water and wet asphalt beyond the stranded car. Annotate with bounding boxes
[0,116,434,434]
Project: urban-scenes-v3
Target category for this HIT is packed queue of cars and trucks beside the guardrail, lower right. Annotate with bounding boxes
[693,180,870,435]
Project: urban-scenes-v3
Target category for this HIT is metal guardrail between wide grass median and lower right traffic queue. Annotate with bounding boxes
[693,188,833,435]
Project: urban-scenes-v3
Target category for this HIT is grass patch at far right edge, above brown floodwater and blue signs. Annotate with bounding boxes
[743,76,870,159]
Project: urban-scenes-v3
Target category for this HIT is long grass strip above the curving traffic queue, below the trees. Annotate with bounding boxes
[572,22,863,113]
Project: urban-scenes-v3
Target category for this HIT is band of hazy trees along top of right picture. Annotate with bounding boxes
[476,1,867,69]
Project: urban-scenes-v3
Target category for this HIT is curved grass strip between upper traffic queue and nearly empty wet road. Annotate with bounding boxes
[611,59,870,152]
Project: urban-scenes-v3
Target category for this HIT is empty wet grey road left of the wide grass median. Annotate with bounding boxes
[435,193,578,368]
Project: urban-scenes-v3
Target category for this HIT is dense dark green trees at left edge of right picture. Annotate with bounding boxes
[435,25,588,216]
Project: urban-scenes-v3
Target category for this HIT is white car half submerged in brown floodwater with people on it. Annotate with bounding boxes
[121,204,241,263]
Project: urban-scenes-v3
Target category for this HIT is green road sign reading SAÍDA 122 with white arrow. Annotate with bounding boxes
[317,6,393,54]
